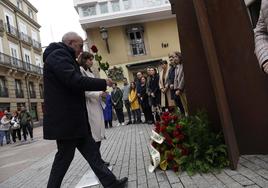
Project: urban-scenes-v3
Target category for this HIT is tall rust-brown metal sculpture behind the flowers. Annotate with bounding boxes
[171,0,268,169]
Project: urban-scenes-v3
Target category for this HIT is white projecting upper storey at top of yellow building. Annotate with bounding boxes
[74,0,172,29]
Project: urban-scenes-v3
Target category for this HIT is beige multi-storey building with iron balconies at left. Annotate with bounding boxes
[0,0,43,120]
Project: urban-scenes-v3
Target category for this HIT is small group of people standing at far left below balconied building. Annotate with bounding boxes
[0,107,33,146]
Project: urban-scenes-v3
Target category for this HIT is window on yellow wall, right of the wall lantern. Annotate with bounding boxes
[127,26,146,55]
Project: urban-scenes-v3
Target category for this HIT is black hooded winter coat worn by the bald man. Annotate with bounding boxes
[43,43,106,140]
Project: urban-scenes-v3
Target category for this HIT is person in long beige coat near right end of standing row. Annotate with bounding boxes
[159,60,175,109]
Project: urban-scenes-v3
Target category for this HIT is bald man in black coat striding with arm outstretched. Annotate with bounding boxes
[43,32,127,188]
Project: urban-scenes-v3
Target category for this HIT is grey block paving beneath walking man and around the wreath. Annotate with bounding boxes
[0,124,268,188]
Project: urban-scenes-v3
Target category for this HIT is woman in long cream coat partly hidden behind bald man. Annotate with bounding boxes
[78,52,109,165]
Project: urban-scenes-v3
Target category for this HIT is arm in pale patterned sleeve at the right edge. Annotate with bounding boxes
[254,0,268,74]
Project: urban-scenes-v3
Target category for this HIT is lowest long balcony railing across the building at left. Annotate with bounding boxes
[0,53,43,75]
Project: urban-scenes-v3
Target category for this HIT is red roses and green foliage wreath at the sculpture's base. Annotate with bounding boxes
[151,112,229,175]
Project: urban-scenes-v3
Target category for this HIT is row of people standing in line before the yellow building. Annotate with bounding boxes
[111,52,188,125]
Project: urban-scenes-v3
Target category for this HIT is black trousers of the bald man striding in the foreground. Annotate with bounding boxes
[47,135,116,188]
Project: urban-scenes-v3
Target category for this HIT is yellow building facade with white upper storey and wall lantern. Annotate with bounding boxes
[74,0,180,83]
